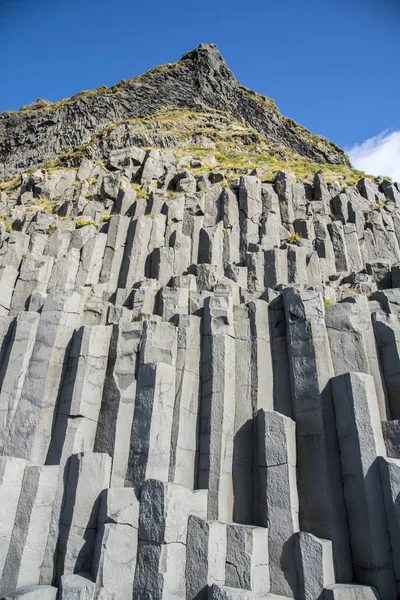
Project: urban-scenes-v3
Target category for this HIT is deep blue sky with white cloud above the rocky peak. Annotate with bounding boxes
[0,0,400,179]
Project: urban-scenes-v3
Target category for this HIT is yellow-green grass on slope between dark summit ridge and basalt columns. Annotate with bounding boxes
[97,105,373,185]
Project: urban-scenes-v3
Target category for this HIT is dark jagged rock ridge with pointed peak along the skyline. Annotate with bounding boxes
[0,44,350,180]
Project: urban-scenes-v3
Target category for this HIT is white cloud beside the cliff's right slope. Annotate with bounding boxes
[346,130,400,181]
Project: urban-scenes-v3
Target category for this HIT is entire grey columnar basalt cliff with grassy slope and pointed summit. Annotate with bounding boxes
[0,45,400,600]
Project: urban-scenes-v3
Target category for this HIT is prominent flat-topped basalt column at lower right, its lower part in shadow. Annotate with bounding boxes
[332,373,397,598]
